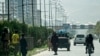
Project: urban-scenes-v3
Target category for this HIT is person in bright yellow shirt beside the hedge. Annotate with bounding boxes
[12,30,20,56]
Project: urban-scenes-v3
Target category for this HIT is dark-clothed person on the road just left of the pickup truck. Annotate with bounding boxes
[51,32,58,55]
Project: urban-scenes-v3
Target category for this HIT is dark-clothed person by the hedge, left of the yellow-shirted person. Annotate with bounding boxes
[1,27,10,56]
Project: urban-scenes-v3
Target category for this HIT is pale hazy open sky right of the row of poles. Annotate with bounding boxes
[60,0,100,24]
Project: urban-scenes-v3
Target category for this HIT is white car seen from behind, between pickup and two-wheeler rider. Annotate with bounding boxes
[74,34,86,45]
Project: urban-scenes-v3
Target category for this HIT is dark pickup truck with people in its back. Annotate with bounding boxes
[57,31,70,51]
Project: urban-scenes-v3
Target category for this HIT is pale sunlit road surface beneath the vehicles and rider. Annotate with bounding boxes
[32,40,100,56]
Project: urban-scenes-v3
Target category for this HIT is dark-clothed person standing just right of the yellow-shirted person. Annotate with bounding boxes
[20,34,27,56]
